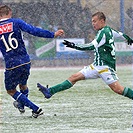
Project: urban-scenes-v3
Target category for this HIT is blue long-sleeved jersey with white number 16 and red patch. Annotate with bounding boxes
[0,18,54,70]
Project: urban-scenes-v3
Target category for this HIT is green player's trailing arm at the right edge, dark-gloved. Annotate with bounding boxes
[112,30,133,45]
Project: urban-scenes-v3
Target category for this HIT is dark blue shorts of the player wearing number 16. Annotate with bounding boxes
[5,64,30,90]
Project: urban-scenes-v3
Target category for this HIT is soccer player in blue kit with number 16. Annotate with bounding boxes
[0,5,64,118]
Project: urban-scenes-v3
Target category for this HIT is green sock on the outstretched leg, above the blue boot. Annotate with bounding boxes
[49,80,73,95]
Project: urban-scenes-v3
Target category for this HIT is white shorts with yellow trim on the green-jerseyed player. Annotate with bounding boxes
[80,64,118,85]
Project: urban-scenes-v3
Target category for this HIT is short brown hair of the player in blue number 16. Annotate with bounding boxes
[0,5,12,17]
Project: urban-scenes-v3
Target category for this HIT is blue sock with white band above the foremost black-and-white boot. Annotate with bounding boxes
[12,91,39,112]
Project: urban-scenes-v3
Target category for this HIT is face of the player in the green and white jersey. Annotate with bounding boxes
[92,16,105,30]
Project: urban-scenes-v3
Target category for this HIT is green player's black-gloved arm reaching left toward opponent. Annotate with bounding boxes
[63,40,95,51]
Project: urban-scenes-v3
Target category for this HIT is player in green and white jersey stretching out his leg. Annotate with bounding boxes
[37,12,133,99]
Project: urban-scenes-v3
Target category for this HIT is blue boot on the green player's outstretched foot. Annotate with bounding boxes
[37,83,52,99]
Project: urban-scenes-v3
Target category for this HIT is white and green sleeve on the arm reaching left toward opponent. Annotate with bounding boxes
[75,41,95,51]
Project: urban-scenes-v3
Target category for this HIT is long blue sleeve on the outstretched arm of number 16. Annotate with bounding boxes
[18,19,54,38]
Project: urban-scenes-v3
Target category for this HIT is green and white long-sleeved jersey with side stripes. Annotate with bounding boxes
[75,26,129,70]
